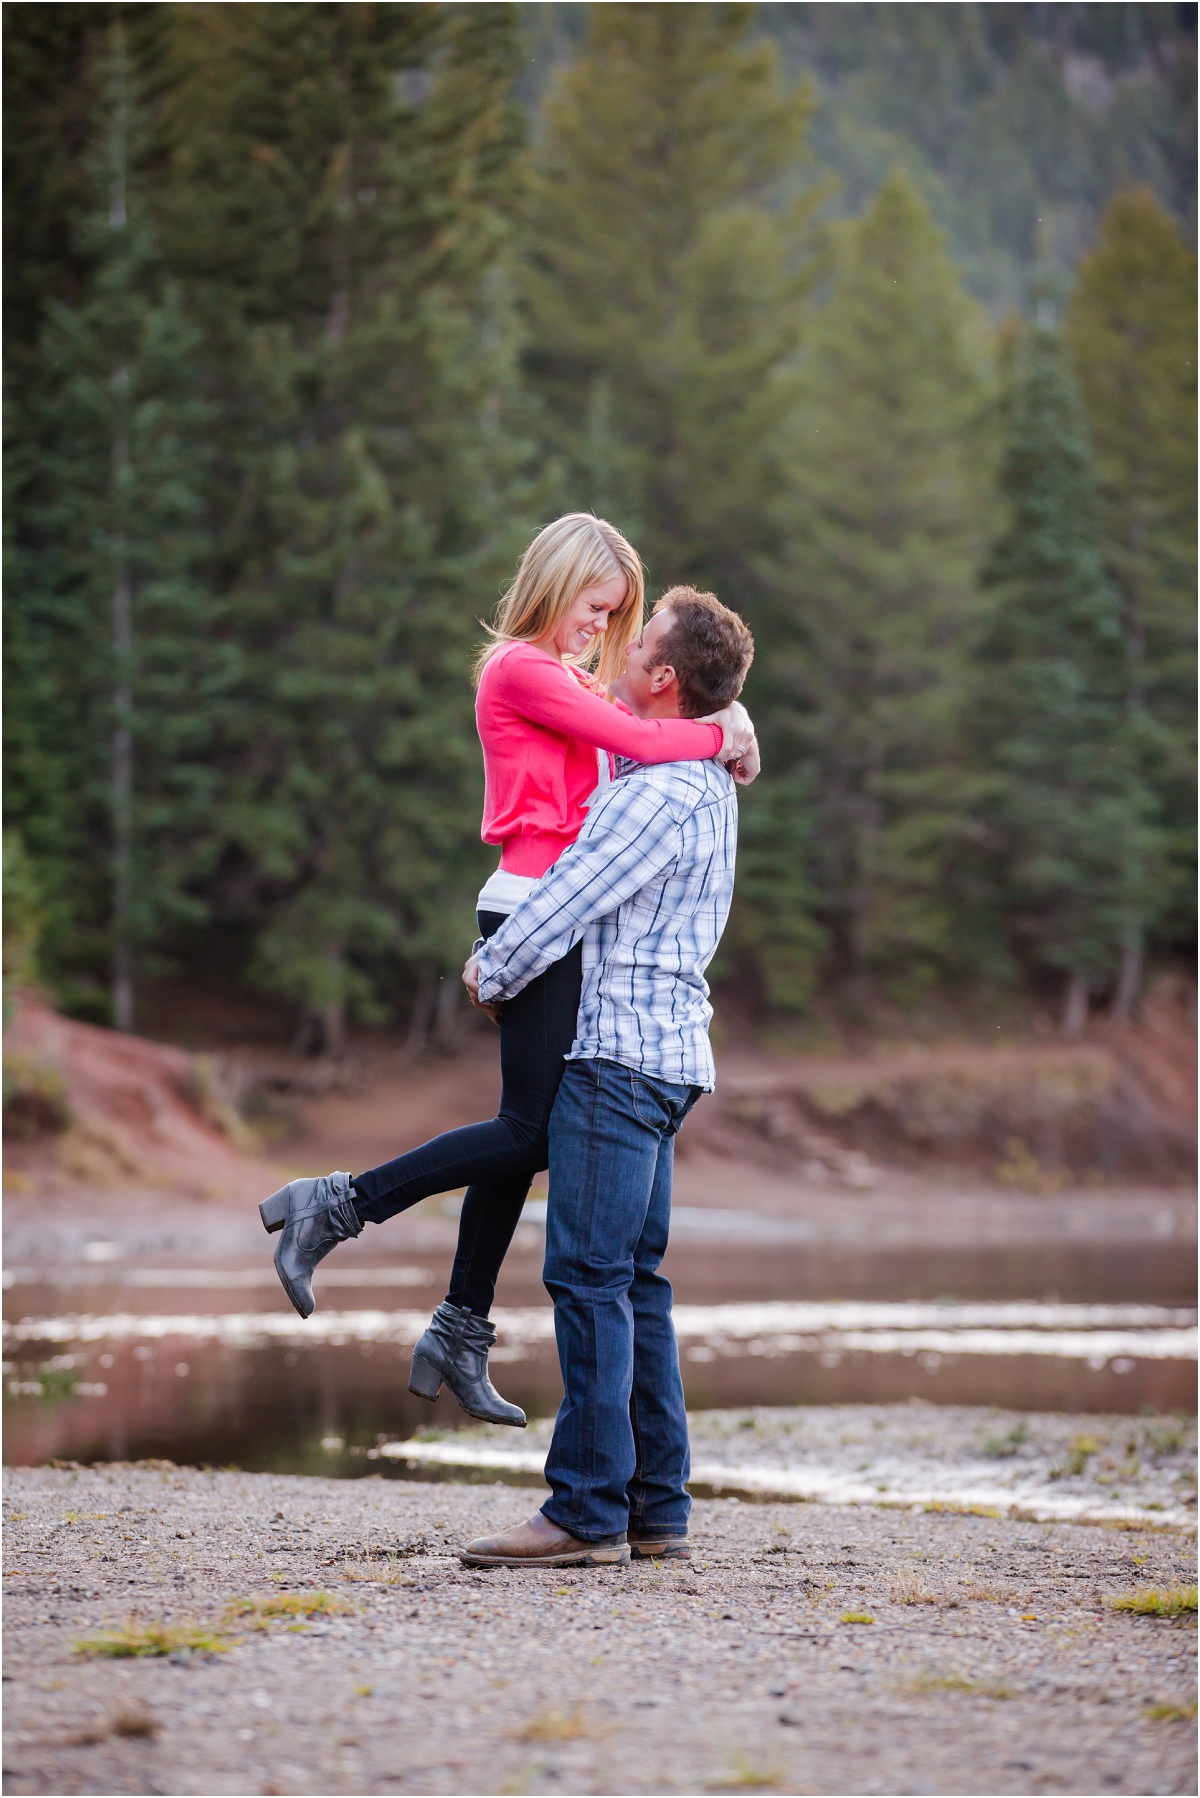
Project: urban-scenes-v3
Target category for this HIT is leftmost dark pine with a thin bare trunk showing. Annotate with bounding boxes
[5,7,219,1028]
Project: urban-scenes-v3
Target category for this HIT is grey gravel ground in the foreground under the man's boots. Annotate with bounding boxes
[4,1459,1195,1794]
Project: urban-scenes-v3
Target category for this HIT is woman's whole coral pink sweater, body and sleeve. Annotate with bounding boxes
[475,644,721,879]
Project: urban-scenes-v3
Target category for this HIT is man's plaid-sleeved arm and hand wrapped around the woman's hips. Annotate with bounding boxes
[462,780,680,1005]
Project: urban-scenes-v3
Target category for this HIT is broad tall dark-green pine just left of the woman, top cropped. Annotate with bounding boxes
[161,4,522,1050]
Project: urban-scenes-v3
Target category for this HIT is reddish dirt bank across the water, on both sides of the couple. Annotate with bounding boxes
[5,982,1196,1203]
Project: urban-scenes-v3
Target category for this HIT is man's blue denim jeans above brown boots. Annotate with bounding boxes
[542,1061,700,1541]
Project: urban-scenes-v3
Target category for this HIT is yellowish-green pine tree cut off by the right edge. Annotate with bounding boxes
[1067,189,1196,1012]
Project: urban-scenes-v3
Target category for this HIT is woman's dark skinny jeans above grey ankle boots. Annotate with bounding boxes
[354,912,583,1318]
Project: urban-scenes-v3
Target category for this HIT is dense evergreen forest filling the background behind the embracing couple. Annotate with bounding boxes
[4,0,1196,1054]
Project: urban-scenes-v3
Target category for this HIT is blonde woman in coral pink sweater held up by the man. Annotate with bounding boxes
[259,512,756,1428]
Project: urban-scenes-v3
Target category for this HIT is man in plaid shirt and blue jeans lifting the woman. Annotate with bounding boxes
[462,586,754,1566]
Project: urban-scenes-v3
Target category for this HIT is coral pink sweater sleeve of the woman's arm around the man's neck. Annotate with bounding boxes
[497,651,723,766]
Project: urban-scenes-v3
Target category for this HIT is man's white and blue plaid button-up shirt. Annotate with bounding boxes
[479,761,738,1091]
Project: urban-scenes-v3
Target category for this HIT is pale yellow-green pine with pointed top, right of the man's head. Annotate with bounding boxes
[756,174,990,994]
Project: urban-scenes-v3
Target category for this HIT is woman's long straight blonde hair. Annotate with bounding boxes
[475,512,646,685]
